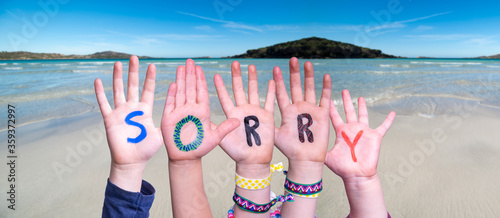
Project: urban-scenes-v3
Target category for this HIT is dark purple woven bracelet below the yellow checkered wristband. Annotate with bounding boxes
[233,190,293,213]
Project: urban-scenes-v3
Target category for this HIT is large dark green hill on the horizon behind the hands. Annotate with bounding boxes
[227,37,401,58]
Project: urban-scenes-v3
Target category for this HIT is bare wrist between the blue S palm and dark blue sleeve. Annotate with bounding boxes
[109,162,146,192]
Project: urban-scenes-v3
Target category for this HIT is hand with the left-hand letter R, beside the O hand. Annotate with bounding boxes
[214,61,275,175]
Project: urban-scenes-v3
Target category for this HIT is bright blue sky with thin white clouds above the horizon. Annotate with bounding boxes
[0,0,500,57]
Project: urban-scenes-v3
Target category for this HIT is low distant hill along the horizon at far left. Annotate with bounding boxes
[0,51,156,60]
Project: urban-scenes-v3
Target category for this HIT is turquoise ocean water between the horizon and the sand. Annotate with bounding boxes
[0,59,500,124]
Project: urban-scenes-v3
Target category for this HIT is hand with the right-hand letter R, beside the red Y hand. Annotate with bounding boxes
[274,58,331,172]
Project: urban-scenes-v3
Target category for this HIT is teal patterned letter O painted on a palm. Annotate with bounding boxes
[174,115,203,152]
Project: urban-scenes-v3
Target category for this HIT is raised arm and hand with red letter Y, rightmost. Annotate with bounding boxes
[325,90,396,218]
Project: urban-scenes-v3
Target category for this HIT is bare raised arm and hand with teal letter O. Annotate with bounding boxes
[161,59,239,217]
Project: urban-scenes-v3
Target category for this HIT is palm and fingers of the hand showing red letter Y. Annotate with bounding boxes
[325,90,396,180]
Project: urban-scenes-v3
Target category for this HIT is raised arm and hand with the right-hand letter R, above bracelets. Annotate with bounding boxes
[273,58,331,218]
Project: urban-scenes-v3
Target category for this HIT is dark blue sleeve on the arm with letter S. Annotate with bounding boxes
[102,179,155,218]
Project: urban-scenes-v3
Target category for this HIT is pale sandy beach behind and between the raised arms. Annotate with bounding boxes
[0,96,500,217]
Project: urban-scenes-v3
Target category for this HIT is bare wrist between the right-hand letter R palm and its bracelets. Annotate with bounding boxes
[287,160,323,184]
